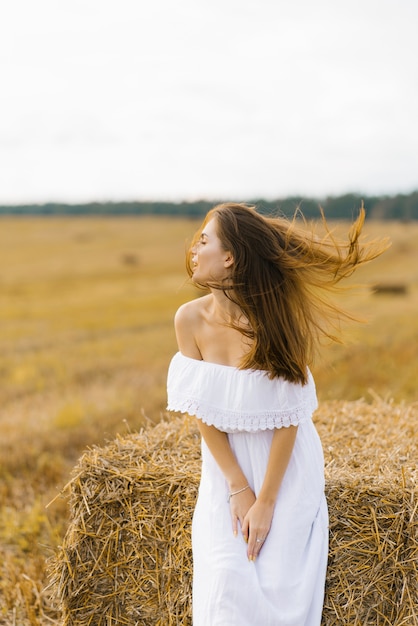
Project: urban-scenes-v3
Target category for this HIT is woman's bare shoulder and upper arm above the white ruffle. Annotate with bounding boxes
[174,296,208,359]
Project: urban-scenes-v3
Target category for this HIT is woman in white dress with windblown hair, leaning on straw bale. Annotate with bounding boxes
[167,203,383,626]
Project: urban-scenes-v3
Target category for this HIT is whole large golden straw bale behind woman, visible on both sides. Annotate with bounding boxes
[51,399,418,626]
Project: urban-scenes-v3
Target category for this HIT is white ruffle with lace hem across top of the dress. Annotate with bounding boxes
[167,352,317,432]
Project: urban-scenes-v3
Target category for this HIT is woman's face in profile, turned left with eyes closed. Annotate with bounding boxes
[191,217,233,285]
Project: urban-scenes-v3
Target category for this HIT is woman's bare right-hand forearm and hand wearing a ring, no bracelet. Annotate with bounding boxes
[242,426,297,561]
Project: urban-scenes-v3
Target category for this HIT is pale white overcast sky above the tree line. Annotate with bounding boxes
[0,0,418,204]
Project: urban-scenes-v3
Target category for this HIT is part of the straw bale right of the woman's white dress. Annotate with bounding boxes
[317,398,418,626]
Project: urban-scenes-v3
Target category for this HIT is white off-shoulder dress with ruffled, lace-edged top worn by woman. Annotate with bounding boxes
[167,352,328,626]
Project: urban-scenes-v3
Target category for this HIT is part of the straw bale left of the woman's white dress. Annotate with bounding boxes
[52,419,199,626]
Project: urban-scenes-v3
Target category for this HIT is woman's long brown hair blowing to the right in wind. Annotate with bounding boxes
[186,203,388,384]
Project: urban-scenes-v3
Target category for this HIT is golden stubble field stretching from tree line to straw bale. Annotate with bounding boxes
[0,213,418,626]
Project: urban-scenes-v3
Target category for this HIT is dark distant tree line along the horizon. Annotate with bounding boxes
[0,191,418,221]
